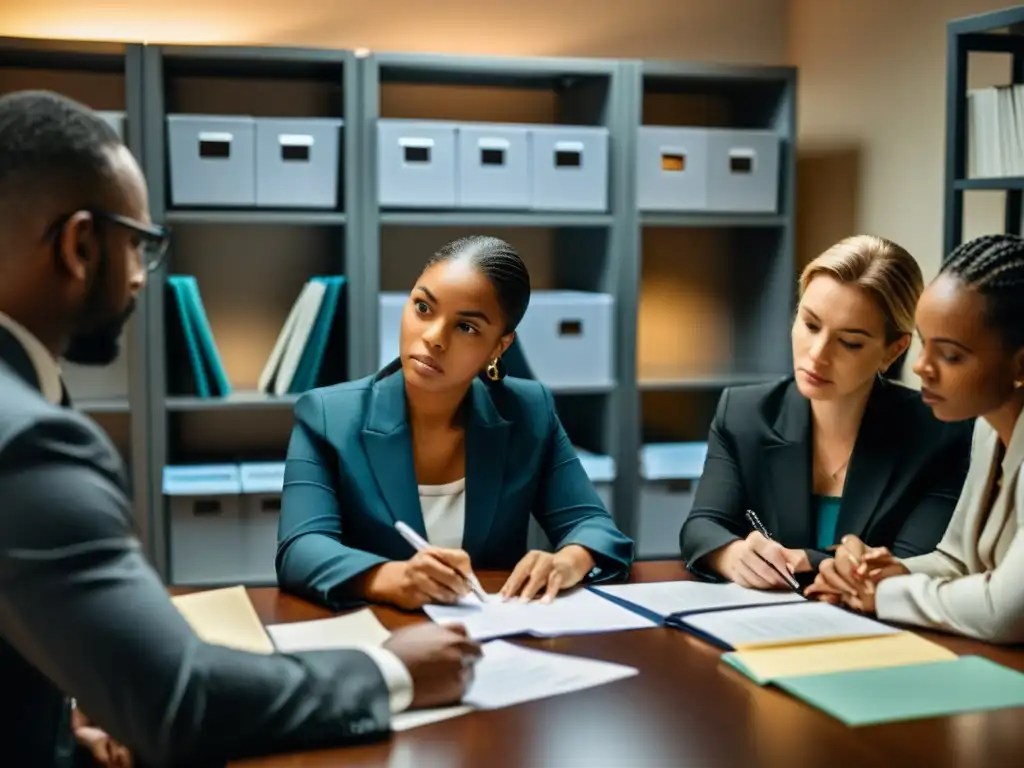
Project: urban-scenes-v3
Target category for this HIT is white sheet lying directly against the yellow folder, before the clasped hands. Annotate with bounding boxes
[685,601,899,650]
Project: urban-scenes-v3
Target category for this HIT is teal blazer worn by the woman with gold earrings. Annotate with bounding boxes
[276,364,633,608]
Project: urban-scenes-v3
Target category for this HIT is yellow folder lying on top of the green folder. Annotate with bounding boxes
[722,632,956,685]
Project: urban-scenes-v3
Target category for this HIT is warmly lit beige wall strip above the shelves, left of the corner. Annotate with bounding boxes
[0,0,787,62]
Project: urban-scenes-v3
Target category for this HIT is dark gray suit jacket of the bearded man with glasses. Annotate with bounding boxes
[0,328,390,768]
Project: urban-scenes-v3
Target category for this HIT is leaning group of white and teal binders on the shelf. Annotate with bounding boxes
[258,275,345,395]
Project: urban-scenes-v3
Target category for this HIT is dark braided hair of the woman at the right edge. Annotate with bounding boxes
[939,234,1024,350]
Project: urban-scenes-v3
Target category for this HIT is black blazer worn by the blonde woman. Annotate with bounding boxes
[679,376,974,581]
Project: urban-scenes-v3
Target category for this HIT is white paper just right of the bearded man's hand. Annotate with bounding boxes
[391,640,638,731]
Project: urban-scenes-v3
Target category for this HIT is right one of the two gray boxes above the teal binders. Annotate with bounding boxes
[256,118,342,208]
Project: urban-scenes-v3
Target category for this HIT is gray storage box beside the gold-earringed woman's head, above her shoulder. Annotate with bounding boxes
[516,291,614,389]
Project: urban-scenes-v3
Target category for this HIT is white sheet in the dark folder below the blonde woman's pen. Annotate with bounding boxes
[594,582,807,616]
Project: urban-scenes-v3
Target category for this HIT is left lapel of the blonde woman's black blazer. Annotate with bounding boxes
[754,382,814,549]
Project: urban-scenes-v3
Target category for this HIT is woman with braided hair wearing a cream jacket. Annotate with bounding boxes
[807,234,1024,643]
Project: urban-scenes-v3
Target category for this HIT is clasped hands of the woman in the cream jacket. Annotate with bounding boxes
[804,536,910,613]
